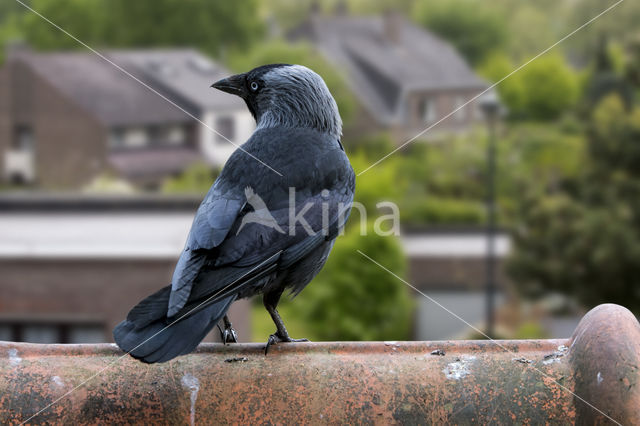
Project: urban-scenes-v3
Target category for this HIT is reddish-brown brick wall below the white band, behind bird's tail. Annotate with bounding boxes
[0,259,251,341]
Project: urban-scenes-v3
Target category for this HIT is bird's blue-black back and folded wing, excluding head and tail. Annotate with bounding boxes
[169,131,355,316]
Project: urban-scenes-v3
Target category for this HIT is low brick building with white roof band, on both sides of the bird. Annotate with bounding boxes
[0,194,524,343]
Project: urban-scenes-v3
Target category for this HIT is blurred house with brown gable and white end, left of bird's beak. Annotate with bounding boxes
[0,45,254,188]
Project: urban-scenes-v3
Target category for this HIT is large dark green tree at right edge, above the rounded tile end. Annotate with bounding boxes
[509,95,640,313]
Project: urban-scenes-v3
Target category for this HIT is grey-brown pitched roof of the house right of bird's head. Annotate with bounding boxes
[289,14,487,124]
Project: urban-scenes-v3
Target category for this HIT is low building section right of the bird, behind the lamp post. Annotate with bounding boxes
[402,228,510,340]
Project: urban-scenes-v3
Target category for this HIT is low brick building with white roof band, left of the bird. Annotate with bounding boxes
[0,195,250,343]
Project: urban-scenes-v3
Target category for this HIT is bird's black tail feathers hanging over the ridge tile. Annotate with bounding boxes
[113,286,236,363]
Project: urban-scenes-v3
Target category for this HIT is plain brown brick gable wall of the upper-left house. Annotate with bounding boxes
[0,60,107,189]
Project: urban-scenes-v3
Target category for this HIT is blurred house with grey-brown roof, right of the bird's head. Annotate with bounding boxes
[288,8,487,142]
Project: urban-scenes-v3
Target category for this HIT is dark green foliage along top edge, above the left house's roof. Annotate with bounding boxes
[21,0,263,55]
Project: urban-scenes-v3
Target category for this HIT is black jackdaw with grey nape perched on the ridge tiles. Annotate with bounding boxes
[113,64,355,363]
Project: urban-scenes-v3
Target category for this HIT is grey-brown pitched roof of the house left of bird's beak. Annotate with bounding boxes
[13,49,243,126]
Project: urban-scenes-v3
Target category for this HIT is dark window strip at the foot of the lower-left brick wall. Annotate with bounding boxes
[0,320,106,343]
